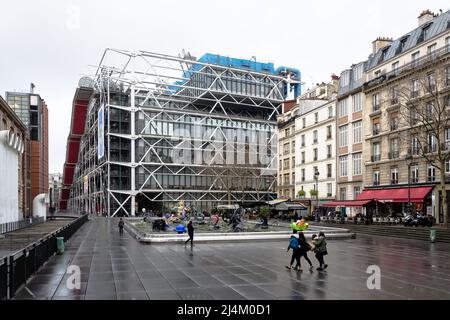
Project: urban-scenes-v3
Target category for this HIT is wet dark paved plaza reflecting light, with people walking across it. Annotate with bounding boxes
[15,218,450,300]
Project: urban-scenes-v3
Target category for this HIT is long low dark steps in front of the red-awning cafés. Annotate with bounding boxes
[314,223,450,243]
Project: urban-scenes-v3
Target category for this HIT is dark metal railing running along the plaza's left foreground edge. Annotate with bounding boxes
[0,214,88,300]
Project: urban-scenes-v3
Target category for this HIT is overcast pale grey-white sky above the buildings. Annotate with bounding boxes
[0,0,449,172]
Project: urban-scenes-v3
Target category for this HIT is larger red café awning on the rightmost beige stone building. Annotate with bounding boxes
[358,187,433,202]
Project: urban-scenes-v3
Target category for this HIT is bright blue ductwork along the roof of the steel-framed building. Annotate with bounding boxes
[169,53,301,98]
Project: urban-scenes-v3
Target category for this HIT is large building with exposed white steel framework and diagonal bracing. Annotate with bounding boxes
[69,49,300,216]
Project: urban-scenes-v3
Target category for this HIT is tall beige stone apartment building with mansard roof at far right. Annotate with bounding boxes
[363,10,450,222]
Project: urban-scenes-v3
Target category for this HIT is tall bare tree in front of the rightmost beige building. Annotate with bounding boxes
[389,65,450,227]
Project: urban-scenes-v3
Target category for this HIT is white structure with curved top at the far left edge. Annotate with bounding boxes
[0,130,24,224]
